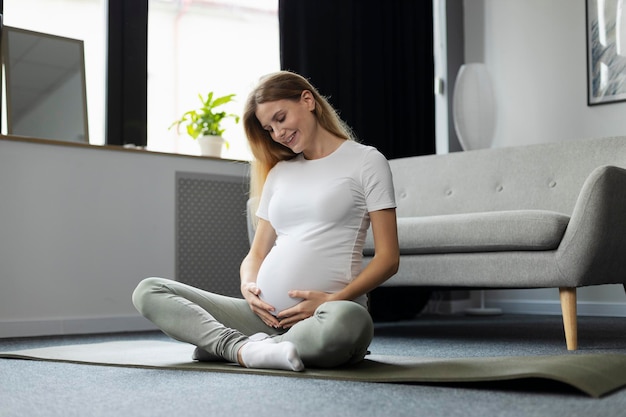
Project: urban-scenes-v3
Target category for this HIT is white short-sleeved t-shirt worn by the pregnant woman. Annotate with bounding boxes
[257,141,396,313]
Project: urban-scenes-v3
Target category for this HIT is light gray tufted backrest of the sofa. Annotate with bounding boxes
[390,137,626,217]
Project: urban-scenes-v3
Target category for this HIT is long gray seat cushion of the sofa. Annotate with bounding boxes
[364,210,569,255]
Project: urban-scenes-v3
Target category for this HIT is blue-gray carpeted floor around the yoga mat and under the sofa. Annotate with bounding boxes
[0,315,626,417]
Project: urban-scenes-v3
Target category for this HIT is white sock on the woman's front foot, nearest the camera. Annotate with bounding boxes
[240,339,304,371]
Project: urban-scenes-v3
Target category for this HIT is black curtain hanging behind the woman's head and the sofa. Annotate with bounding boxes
[279,0,435,159]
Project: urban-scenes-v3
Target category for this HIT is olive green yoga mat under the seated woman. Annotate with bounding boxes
[0,340,626,398]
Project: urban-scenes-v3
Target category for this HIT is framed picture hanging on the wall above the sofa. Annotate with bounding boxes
[587,0,626,106]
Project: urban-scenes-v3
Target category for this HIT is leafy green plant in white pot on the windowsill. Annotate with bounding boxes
[170,91,239,157]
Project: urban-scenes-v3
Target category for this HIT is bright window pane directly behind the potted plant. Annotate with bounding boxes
[148,0,280,160]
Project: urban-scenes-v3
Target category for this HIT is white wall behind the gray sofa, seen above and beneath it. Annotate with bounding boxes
[464,0,626,316]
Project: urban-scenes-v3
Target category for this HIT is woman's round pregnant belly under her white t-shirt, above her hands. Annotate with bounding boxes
[257,240,345,314]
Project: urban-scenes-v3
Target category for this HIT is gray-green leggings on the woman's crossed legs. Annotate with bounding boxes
[133,278,374,368]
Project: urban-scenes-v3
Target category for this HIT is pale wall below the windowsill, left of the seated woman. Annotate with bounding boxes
[0,139,248,337]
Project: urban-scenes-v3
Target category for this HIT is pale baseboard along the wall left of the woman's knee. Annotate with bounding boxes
[0,316,156,338]
